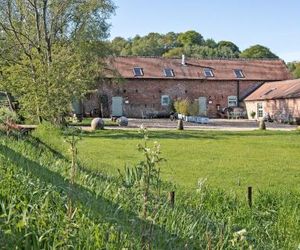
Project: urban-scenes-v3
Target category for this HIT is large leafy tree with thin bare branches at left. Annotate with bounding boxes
[0,0,114,122]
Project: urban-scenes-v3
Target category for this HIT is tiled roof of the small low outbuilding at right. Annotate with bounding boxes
[245,79,300,101]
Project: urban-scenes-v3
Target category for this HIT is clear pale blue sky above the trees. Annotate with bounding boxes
[110,0,300,62]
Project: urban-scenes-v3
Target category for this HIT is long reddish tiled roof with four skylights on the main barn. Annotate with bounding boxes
[106,56,291,81]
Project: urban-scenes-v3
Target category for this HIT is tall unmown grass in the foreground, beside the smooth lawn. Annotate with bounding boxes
[0,127,300,249]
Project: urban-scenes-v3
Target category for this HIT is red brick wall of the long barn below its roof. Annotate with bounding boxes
[84,79,264,117]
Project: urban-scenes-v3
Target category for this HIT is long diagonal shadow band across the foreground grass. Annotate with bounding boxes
[0,145,186,249]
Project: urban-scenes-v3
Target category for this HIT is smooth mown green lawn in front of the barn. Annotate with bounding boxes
[79,130,300,191]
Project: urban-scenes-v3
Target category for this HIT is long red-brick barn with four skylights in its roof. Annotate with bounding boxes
[83,56,291,117]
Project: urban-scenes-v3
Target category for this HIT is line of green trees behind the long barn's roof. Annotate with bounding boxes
[109,30,279,59]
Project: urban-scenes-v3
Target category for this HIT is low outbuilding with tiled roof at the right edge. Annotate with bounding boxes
[244,79,300,122]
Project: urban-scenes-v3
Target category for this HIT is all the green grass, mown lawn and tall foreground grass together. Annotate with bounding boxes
[0,124,300,247]
